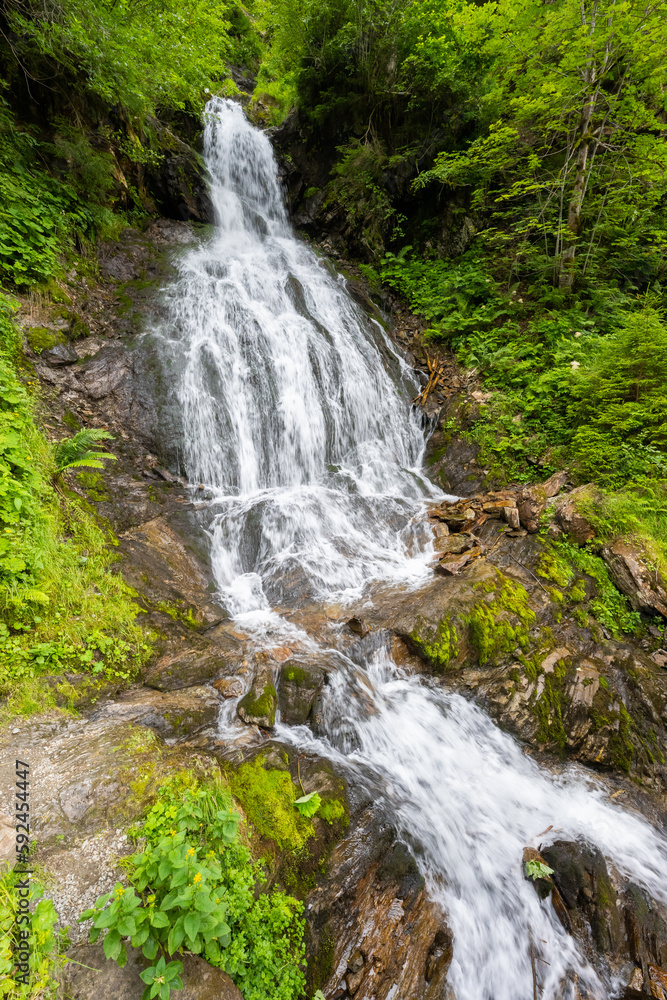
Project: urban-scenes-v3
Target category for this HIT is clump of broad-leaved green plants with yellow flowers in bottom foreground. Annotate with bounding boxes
[79,777,304,1000]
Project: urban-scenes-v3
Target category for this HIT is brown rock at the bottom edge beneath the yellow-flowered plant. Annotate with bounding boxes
[66,944,242,1000]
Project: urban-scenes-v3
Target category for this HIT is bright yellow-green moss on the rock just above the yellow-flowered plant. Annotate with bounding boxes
[229,754,315,854]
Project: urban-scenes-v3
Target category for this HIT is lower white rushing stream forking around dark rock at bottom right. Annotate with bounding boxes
[279,653,667,1000]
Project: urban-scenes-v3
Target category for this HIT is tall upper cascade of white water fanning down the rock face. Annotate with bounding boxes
[156,98,435,613]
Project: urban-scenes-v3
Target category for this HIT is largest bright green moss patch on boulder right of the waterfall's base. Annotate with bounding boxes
[467,573,535,664]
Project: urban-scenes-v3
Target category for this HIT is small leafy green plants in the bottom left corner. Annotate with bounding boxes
[0,870,67,1000]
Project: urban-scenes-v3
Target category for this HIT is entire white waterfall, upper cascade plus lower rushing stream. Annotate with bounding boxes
[157,98,667,1000]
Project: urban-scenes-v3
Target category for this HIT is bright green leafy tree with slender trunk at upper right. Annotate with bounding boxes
[421,0,667,291]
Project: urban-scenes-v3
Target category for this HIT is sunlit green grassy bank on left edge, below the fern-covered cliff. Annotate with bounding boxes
[0,296,149,712]
